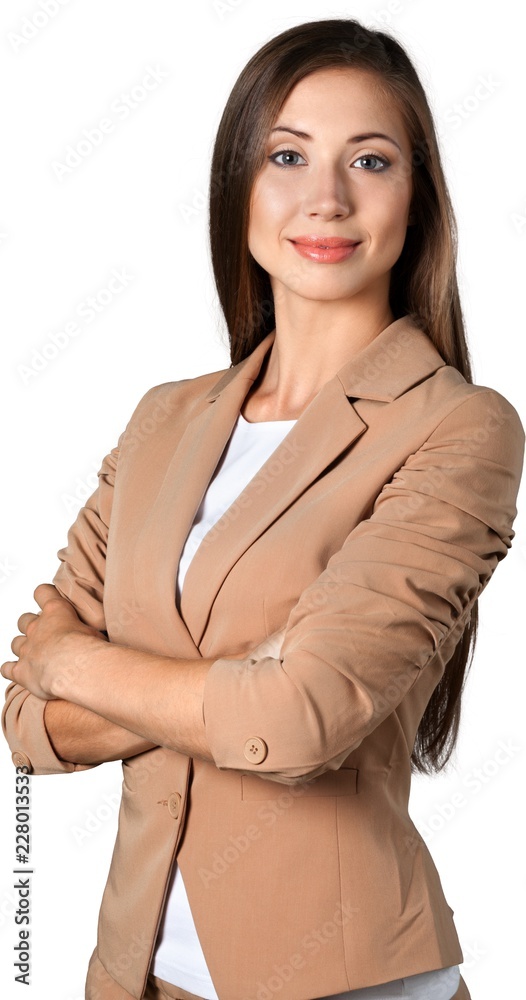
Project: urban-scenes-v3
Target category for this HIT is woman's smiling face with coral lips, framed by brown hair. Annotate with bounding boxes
[248,67,412,307]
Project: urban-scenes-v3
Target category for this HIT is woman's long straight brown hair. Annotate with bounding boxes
[209,18,478,773]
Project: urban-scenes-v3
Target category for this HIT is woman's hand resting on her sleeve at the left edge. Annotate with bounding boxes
[0,583,106,700]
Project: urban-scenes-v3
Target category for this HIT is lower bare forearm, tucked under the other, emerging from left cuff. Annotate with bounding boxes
[44,698,156,764]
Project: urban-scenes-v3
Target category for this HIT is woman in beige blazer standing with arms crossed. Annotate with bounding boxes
[2,20,524,1000]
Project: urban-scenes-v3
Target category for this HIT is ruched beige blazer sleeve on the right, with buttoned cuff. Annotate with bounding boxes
[203,387,524,784]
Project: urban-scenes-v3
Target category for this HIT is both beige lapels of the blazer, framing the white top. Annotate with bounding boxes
[131,317,445,655]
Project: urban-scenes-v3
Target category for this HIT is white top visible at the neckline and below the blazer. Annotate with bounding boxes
[151,413,460,1000]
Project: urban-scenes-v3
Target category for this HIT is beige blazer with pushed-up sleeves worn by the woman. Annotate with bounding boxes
[4,318,524,1000]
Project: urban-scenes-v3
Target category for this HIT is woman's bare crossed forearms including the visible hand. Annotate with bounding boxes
[1,584,276,766]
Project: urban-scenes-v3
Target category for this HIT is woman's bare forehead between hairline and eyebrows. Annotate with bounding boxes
[273,66,406,138]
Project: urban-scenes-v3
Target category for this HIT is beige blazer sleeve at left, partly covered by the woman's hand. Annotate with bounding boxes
[2,435,122,774]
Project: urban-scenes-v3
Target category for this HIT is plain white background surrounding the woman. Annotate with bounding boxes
[0,0,526,1000]
